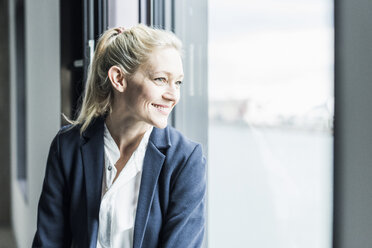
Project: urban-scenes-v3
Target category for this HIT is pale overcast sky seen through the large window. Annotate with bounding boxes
[208,0,334,114]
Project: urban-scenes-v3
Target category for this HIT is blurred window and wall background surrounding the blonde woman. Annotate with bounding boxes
[0,0,372,248]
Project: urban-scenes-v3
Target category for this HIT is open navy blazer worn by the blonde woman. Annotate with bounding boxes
[32,118,206,248]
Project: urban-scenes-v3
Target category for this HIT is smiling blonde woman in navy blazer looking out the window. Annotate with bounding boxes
[33,25,206,248]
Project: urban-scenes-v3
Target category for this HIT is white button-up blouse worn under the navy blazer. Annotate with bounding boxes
[97,124,152,248]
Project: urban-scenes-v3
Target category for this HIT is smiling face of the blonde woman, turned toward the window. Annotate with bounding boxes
[123,48,183,128]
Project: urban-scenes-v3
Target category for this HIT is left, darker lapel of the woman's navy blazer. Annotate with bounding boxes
[81,118,104,247]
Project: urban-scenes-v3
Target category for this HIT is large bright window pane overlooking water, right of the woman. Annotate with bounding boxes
[208,0,334,248]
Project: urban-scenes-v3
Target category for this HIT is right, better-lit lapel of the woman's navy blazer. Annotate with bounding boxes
[133,127,171,248]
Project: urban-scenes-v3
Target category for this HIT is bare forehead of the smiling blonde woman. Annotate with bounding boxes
[145,47,183,76]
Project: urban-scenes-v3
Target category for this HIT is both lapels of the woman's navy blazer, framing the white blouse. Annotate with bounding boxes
[81,117,171,248]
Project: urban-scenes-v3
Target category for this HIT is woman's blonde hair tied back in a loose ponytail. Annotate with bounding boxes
[70,24,182,133]
